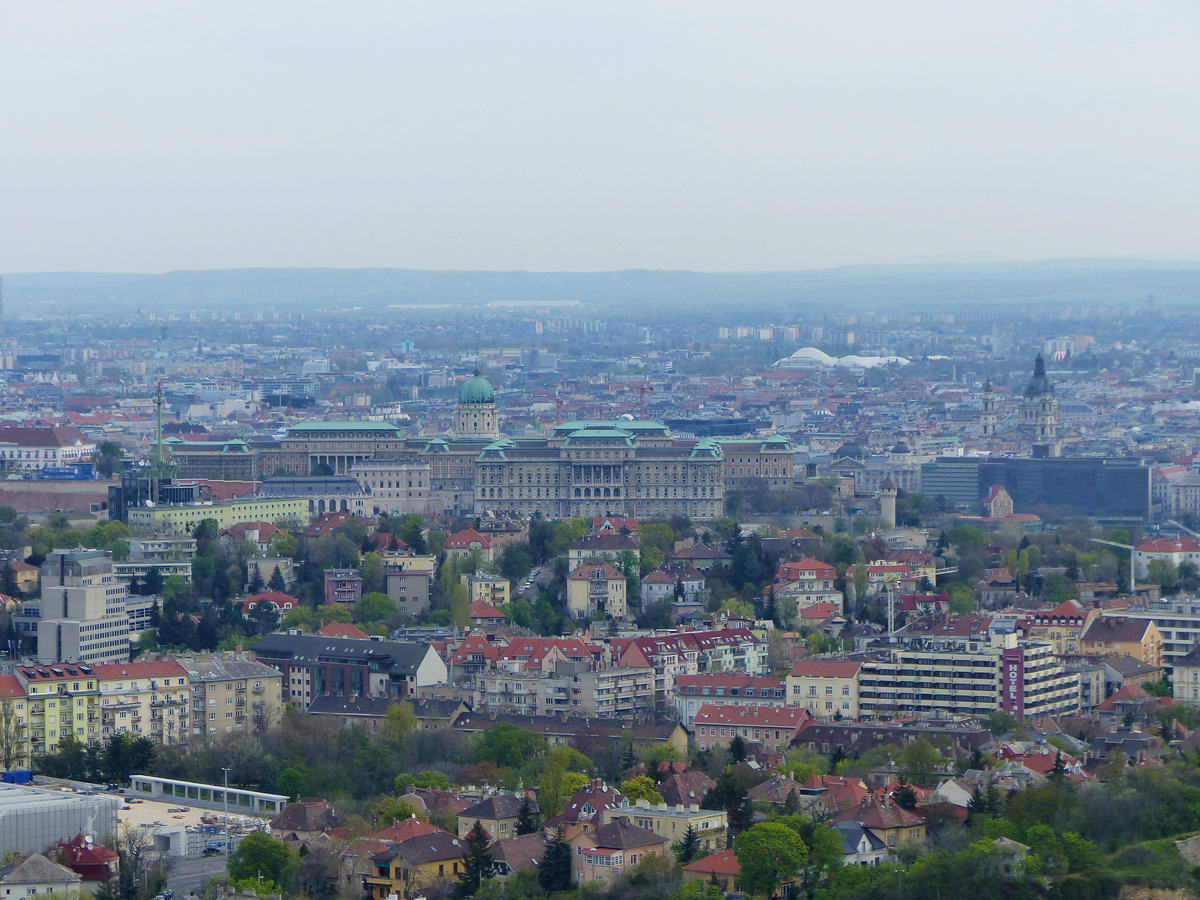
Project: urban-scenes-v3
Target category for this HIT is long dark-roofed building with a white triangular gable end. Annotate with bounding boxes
[254,634,448,708]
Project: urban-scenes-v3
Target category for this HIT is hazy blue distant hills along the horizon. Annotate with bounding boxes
[4,259,1200,317]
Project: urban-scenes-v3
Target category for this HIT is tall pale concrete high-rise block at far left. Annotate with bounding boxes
[14,550,130,662]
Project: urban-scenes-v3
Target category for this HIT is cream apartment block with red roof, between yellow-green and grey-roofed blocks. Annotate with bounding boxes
[92,660,192,744]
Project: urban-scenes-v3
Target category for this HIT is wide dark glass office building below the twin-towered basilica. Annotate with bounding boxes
[920,457,1151,522]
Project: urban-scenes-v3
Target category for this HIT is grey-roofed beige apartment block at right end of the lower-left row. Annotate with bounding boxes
[180,654,283,739]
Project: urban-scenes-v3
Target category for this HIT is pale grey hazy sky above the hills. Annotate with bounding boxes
[0,0,1200,271]
